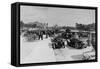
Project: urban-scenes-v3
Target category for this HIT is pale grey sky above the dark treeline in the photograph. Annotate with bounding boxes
[20,6,95,27]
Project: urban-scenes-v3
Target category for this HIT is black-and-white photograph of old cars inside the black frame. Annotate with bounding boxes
[20,5,96,64]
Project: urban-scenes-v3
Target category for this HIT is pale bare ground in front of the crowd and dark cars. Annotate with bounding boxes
[20,37,93,63]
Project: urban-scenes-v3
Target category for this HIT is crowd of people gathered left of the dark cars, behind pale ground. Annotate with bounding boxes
[24,30,55,40]
